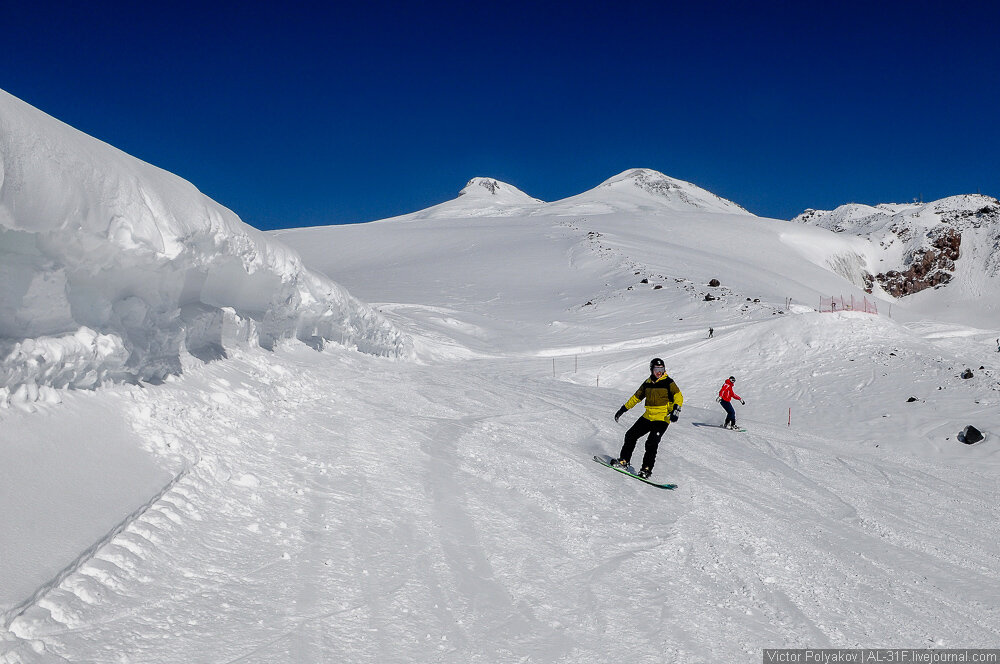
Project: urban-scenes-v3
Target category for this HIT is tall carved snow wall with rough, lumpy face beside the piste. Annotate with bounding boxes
[0,90,412,405]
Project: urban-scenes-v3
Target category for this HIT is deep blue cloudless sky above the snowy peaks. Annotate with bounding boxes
[0,1,1000,229]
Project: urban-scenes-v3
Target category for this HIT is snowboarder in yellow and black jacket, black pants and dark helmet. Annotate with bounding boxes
[613,357,684,479]
